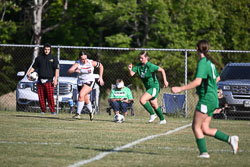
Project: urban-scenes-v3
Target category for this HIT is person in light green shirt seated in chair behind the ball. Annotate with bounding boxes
[109,79,133,116]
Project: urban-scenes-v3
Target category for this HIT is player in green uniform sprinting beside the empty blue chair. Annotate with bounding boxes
[128,51,168,124]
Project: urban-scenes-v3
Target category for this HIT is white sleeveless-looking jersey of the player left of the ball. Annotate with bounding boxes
[76,59,95,85]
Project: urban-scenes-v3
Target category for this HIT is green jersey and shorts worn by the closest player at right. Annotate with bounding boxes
[195,57,219,116]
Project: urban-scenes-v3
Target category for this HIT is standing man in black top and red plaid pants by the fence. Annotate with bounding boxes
[27,43,59,115]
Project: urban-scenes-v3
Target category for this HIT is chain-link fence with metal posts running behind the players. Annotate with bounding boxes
[0,44,250,117]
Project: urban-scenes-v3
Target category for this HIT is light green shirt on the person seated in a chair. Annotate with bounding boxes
[109,86,133,100]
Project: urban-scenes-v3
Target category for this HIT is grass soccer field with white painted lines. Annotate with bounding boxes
[0,111,250,167]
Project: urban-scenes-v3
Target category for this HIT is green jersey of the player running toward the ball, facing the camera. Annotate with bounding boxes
[132,62,160,90]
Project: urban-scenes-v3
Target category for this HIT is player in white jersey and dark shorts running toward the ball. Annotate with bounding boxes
[68,51,104,121]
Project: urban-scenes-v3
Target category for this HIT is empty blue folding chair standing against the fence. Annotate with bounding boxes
[161,93,185,114]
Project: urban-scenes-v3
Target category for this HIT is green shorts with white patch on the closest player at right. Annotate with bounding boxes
[196,100,218,117]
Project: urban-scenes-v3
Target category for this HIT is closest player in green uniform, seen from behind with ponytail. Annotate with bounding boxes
[172,40,239,158]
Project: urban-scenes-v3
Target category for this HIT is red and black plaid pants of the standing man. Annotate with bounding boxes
[37,82,55,112]
